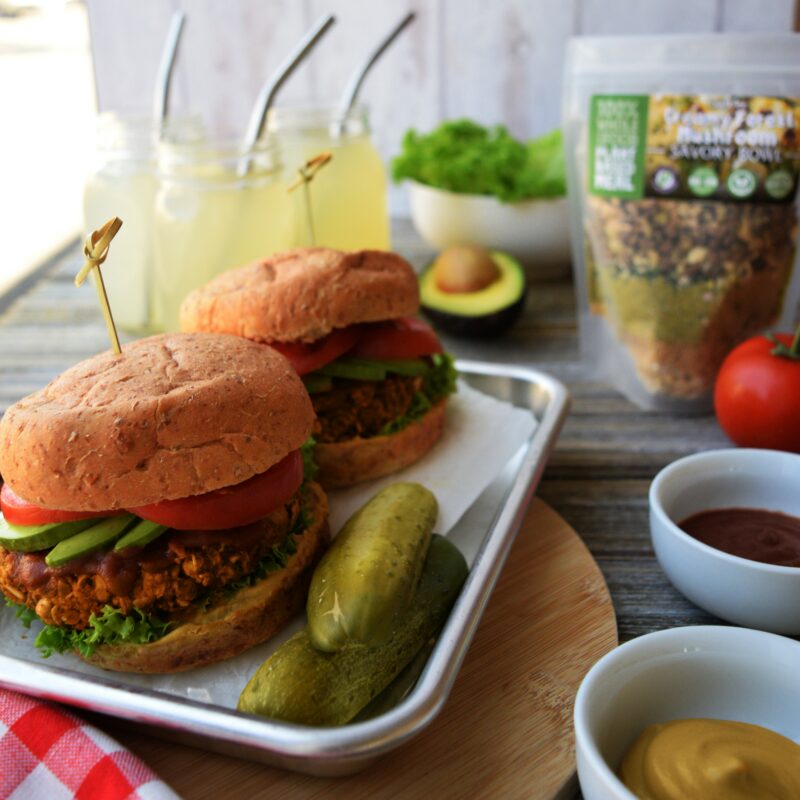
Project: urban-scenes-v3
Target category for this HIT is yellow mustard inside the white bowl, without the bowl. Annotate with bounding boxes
[619,719,800,800]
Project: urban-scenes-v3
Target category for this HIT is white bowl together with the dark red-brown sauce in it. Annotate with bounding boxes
[650,449,800,635]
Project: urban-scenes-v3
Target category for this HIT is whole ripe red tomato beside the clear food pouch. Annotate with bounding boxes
[714,333,800,453]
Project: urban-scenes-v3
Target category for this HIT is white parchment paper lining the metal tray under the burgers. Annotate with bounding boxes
[0,382,536,708]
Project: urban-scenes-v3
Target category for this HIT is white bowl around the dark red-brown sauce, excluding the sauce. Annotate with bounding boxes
[650,449,800,634]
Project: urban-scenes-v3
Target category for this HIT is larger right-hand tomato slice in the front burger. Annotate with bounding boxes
[128,450,303,531]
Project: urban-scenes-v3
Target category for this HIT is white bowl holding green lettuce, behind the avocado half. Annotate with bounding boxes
[408,181,570,280]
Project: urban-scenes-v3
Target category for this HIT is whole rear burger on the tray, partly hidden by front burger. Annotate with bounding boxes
[181,247,456,489]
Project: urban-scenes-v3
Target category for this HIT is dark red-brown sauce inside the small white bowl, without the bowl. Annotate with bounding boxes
[679,508,800,567]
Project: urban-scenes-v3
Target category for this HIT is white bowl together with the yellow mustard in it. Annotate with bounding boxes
[574,626,800,800]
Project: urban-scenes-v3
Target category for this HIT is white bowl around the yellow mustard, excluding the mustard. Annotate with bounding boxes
[575,626,800,800]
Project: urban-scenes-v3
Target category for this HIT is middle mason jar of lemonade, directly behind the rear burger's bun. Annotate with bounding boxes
[152,134,299,331]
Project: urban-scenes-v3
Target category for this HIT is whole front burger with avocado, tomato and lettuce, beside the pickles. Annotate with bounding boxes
[0,334,328,672]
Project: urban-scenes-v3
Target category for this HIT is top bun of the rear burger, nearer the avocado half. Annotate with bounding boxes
[181,247,419,342]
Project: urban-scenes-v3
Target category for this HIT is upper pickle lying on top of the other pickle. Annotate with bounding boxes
[306,483,438,653]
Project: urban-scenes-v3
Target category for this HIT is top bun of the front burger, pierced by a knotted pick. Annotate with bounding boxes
[0,333,314,511]
